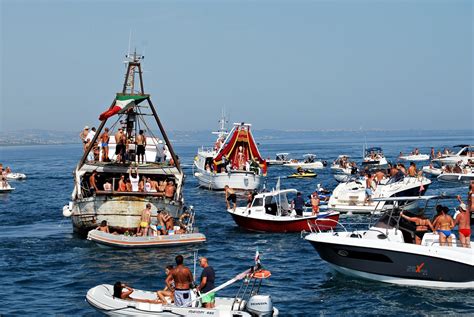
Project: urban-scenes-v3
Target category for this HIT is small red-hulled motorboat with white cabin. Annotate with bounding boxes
[227,189,339,232]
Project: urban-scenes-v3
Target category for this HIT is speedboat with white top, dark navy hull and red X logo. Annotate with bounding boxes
[305,196,474,289]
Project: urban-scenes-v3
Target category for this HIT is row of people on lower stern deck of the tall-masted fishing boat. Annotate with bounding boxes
[86,168,176,200]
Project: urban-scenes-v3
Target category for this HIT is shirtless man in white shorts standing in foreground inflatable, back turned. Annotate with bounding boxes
[171,255,193,307]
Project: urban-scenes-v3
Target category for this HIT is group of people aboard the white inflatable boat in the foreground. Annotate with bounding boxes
[113,255,216,308]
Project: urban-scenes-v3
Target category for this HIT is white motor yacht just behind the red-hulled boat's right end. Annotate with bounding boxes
[328,176,431,214]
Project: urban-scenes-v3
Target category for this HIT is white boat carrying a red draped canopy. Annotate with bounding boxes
[194,118,267,190]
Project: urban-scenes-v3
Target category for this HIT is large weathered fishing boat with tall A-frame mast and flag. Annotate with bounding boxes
[63,52,184,236]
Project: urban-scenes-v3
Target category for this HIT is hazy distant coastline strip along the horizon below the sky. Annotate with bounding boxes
[0,129,474,146]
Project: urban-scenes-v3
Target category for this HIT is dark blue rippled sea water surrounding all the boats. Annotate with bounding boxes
[0,133,474,316]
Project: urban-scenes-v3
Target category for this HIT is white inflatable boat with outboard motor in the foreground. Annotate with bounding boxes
[86,258,279,317]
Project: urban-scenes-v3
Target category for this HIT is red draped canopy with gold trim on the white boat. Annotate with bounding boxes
[214,124,266,170]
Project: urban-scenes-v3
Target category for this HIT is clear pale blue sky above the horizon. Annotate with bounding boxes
[0,0,474,132]
